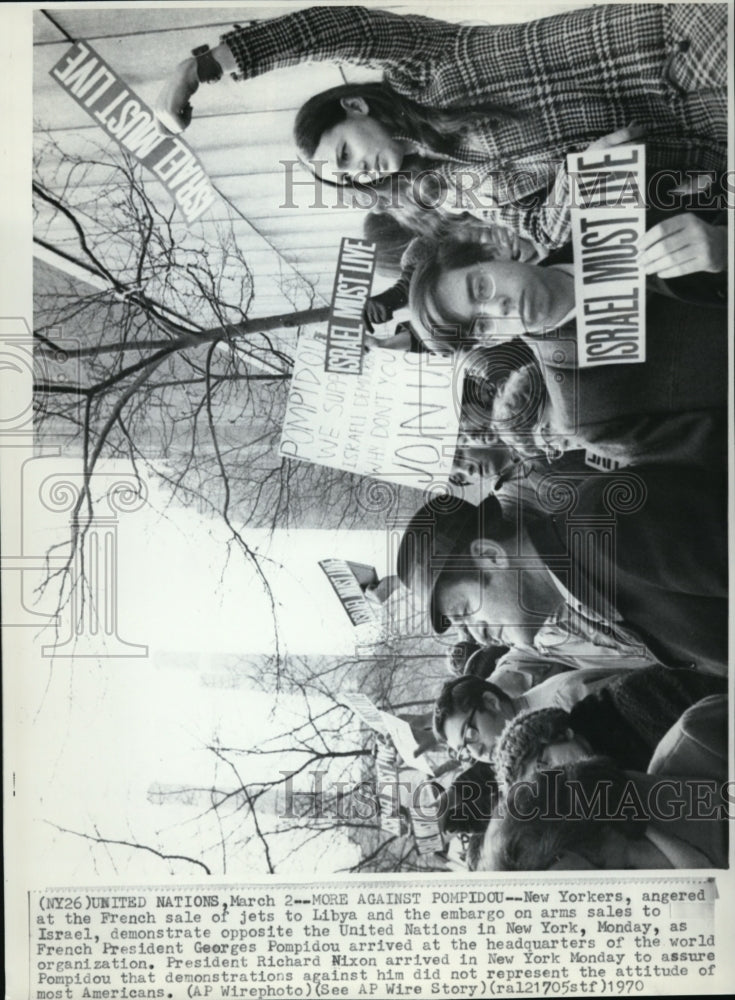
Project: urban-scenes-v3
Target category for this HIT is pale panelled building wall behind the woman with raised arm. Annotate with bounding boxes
[34,2,569,315]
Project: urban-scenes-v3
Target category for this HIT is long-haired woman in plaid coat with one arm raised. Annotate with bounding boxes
[157,4,727,247]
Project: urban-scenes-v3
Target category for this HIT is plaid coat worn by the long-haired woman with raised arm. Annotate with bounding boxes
[222,3,728,247]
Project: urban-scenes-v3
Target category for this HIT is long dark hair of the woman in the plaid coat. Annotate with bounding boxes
[294,81,523,160]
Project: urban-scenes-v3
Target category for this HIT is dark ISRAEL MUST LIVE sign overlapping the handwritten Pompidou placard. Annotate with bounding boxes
[324,237,376,375]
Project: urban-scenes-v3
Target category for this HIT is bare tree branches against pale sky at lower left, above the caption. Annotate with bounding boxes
[144,656,452,873]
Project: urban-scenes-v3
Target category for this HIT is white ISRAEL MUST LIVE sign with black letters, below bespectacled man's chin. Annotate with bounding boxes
[567,145,646,368]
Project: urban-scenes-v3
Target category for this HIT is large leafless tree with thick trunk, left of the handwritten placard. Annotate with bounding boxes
[33,135,420,648]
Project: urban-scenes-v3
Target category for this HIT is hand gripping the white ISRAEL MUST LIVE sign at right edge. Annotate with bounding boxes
[640,212,727,279]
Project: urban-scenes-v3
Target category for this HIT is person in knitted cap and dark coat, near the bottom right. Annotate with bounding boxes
[493,666,727,787]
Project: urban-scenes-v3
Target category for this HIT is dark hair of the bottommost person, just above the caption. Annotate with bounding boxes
[493,757,648,871]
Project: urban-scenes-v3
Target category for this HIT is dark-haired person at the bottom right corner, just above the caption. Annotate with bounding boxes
[478,757,727,871]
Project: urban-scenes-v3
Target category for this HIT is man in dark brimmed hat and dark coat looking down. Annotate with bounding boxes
[397,482,728,674]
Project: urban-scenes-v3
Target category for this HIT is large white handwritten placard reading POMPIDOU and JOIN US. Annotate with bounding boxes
[280,334,463,490]
